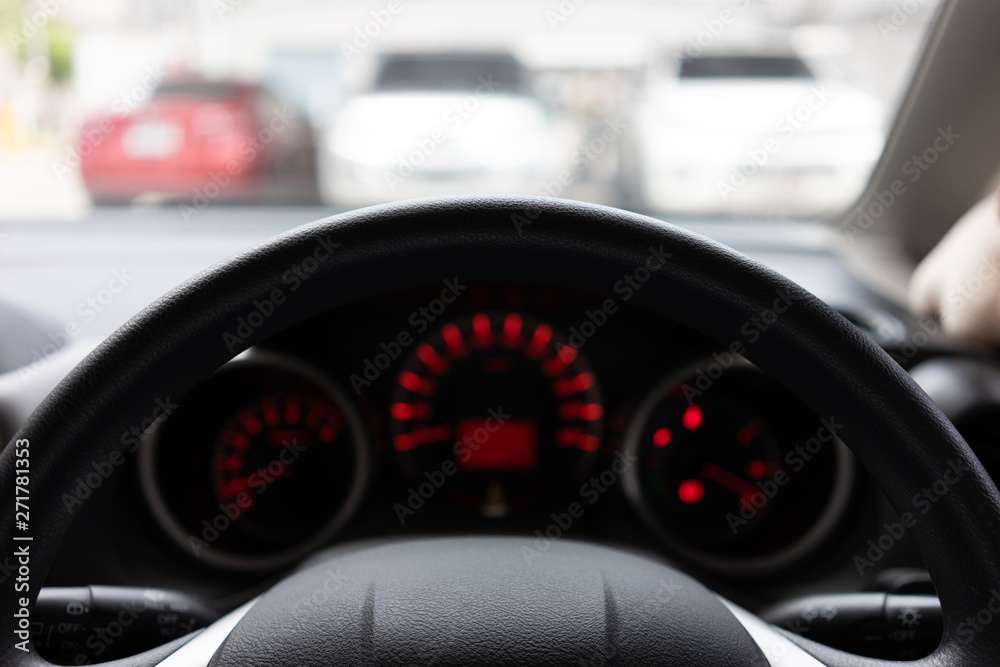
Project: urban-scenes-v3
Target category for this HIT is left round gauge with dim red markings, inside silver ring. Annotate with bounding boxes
[140,353,369,570]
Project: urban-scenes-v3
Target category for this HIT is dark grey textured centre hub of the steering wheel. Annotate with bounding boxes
[213,537,768,667]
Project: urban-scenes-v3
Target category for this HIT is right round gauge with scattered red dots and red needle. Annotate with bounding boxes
[623,359,854,573]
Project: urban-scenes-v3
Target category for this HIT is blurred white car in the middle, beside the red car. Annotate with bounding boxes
[319,54,561,206]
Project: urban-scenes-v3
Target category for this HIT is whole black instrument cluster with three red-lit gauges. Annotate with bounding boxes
[139,279,854,574]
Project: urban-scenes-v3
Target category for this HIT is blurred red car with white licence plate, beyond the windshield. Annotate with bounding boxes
[78,81,316,206]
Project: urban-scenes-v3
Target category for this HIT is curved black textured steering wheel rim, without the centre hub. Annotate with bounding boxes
[0,197,1000,665]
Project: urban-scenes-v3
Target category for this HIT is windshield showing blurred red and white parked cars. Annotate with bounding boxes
[0,0,937,223]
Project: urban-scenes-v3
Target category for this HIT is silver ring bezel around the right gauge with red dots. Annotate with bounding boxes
[622,356,856,575]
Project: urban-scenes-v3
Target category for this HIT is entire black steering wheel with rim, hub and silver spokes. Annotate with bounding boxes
[0,197,1000,667]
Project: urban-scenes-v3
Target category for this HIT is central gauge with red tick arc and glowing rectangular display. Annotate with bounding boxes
[390,312,604,517]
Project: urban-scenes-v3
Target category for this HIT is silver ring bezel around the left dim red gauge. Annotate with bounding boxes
[138,348,373,572]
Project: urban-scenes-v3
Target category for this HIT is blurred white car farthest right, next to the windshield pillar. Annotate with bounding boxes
[635,55,885,216]
